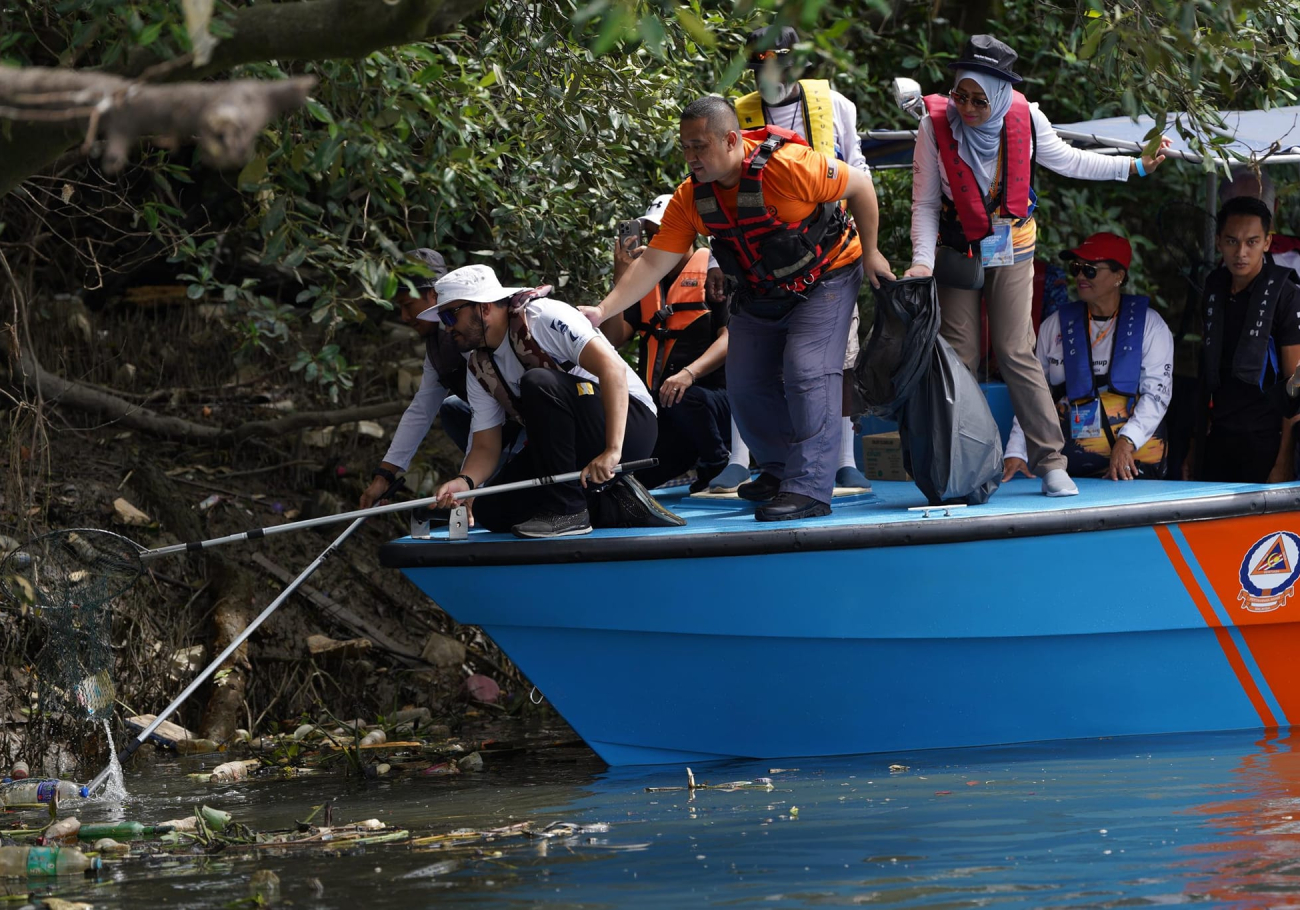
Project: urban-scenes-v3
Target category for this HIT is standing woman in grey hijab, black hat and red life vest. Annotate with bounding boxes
[906,35,1169,497]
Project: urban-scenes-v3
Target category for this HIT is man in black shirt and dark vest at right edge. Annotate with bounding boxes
[1183,196,1300,484]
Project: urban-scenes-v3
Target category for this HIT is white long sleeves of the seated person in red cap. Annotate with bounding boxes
[1004,308,1174,460]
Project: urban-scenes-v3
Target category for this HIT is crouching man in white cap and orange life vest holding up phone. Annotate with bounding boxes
[601,195,731,493]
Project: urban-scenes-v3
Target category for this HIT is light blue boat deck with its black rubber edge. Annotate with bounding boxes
[381,477,1300,568]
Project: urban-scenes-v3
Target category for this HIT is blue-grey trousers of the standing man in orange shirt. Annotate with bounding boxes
[727,263,862,504]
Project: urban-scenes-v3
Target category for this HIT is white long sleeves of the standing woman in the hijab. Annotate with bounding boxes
[911,101,1130,268]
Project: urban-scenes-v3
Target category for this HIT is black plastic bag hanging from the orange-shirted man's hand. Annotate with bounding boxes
[853,278,940,420]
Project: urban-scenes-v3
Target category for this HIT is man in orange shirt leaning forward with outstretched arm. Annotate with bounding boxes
[580,95,893,521]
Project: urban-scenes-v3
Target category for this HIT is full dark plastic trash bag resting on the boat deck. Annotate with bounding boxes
[898,338,1002,506]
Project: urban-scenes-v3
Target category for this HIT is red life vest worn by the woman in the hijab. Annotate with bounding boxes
[924,91,1034,246]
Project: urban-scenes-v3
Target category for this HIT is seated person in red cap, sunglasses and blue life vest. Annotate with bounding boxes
[1002,233,1174,480]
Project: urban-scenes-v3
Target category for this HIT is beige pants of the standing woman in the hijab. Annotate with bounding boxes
[939,259,1066,477]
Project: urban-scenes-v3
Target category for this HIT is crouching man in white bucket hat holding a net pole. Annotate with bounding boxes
[431,265,684,537]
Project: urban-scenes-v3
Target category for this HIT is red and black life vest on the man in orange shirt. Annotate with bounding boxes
[692,126,857,299]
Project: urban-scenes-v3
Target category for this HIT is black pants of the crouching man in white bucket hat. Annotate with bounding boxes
[475,369,658,532]
